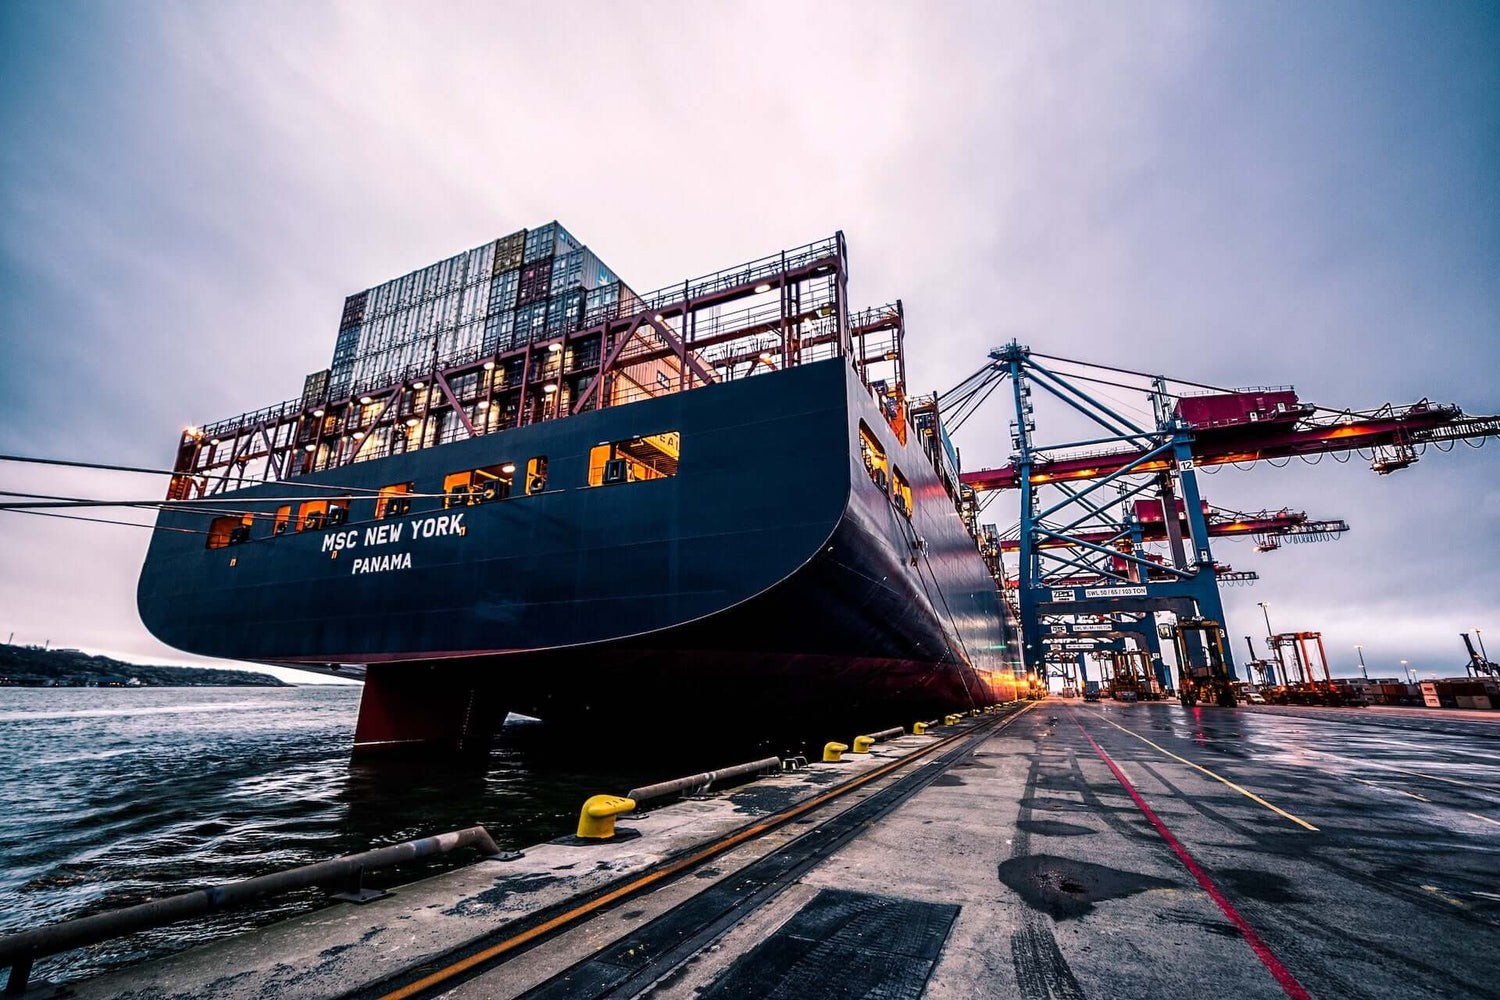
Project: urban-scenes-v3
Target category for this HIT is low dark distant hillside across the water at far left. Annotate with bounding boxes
[0,646,296,688]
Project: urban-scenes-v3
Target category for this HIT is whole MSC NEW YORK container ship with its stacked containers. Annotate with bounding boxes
[138,222,1023,753]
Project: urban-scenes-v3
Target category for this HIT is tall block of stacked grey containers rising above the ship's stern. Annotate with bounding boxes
[325,222,641,399]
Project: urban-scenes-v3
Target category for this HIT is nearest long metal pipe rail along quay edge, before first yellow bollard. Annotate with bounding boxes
[0,826,504,997]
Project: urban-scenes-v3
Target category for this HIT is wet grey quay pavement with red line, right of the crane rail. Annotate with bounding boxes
[651,700,1500,1000]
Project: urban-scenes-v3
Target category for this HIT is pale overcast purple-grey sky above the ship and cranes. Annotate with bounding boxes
[0,0,1500,675]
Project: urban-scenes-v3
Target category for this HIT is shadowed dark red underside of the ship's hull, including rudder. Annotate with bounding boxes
[354,649,1017,754]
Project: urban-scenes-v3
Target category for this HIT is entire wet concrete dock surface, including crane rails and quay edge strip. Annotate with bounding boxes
[55,700,1500,1000]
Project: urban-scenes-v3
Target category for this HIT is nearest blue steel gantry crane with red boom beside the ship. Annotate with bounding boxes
[932,342,1500,689]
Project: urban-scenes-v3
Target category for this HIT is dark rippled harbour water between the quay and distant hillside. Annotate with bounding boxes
[0,687,657,982]
